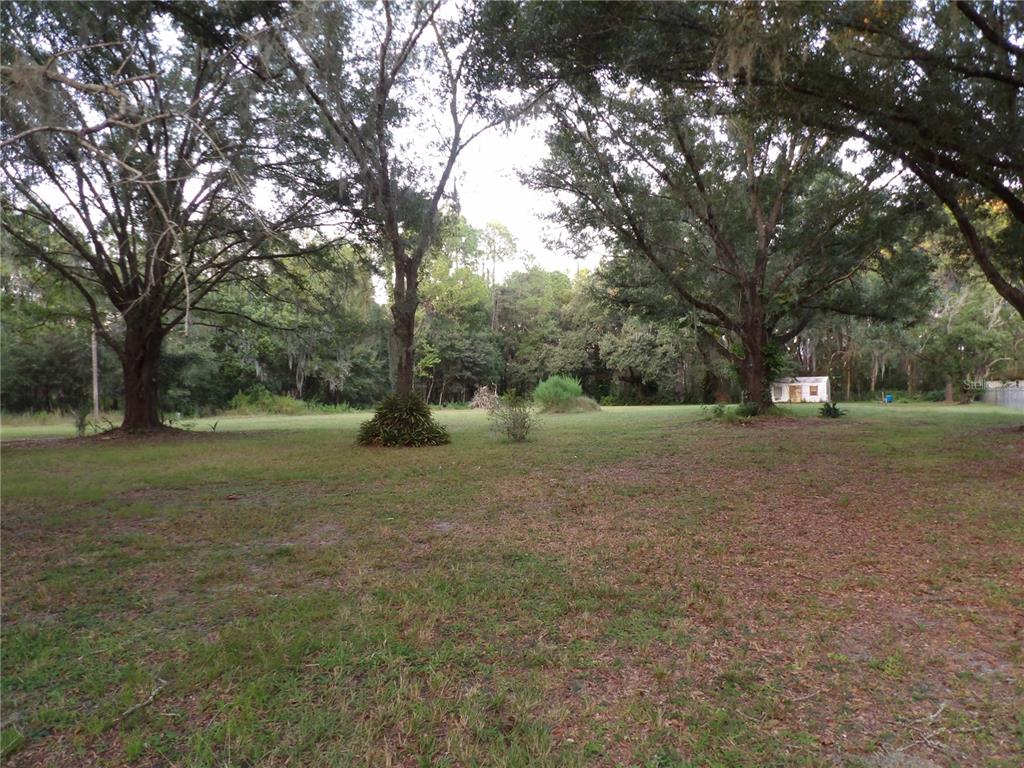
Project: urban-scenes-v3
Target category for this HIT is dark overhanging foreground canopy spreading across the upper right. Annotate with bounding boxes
[474,0,1024,314]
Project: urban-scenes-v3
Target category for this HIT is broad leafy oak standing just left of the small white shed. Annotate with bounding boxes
[532,86,920,410]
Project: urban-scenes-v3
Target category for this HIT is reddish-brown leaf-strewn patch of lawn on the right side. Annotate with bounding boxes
[479,421,1024,765]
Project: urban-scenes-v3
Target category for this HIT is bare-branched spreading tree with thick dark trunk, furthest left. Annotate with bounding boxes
[0,2,319,430]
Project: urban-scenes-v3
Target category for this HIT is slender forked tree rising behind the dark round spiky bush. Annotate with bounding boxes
[262,0,548,409]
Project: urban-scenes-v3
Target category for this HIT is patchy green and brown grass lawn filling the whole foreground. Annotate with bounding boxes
[2,406,1024,768]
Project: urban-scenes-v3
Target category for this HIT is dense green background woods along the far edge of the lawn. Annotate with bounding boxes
[0,211,1024,419]
